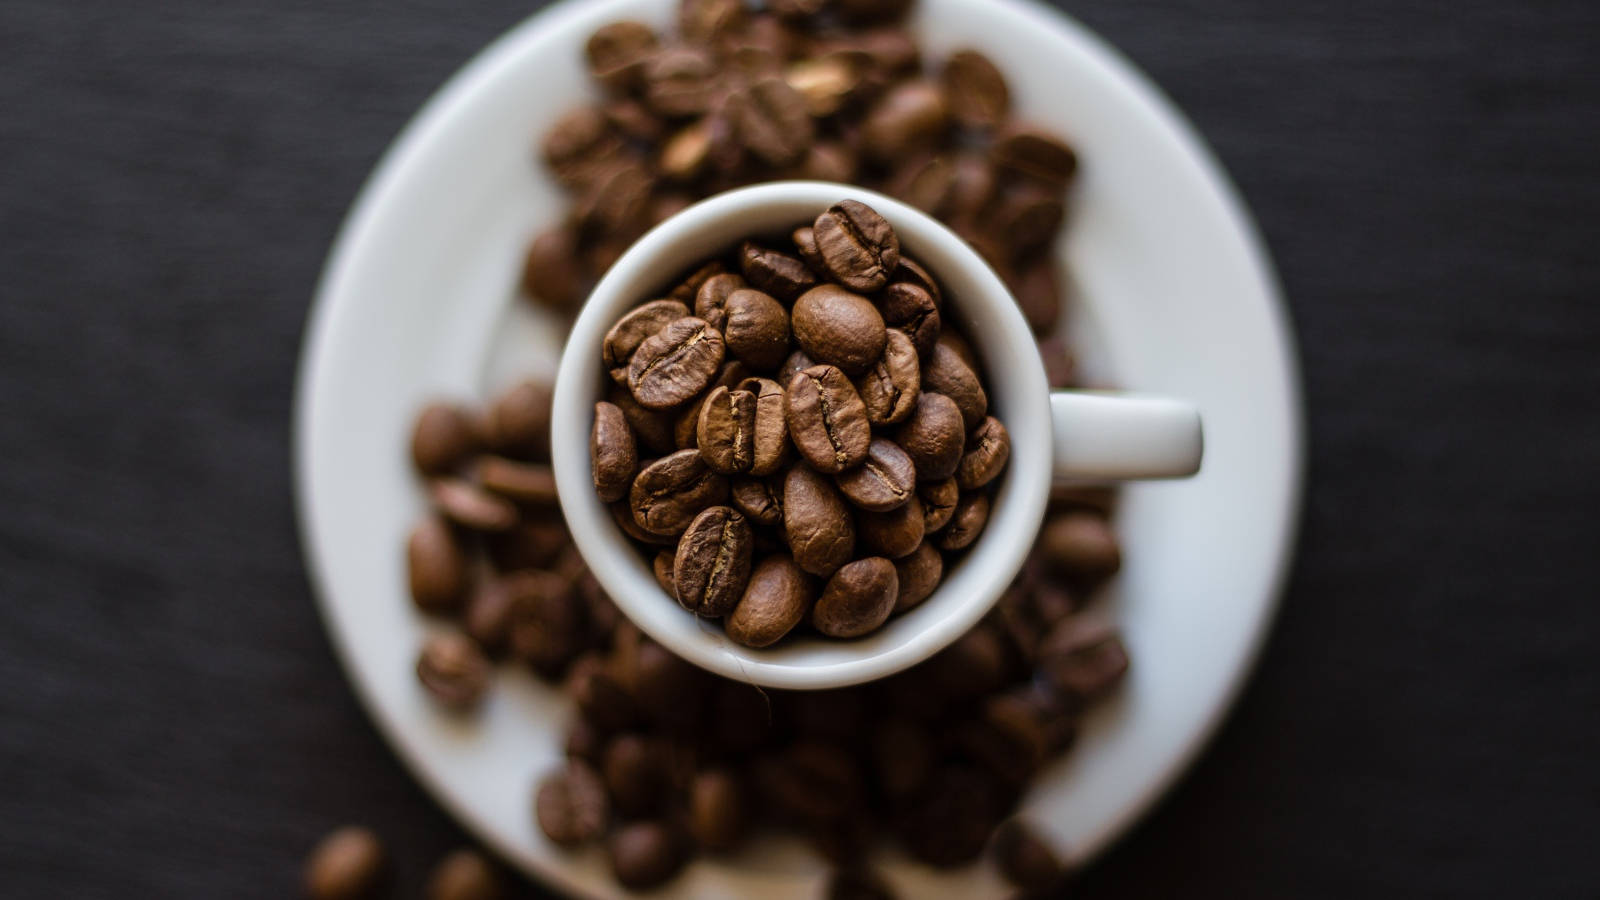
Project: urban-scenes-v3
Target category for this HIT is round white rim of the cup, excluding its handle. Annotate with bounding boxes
[550,181,1051,690]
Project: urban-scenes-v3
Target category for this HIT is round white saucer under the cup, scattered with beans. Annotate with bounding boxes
[294,0,1301,900]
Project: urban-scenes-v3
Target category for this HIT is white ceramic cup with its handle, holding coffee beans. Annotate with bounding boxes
[550,181,1202,689]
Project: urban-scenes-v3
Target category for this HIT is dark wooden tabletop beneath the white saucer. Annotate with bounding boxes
[0,0,1600,898]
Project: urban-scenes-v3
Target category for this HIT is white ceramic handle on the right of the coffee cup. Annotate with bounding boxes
[1050,391,1205,482]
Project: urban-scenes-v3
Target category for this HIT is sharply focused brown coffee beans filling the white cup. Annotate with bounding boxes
[590,200,1011,647]
